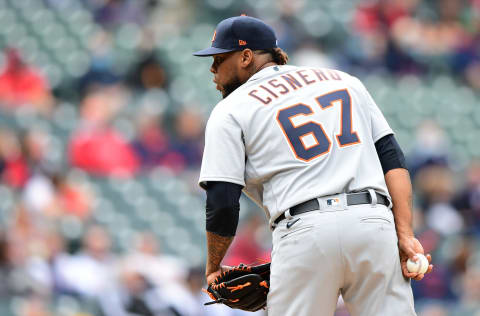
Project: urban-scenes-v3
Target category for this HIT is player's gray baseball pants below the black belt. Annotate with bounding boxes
[267,197,416,316]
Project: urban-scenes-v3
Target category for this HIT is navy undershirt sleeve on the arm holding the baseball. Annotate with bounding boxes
[375,134,407,174]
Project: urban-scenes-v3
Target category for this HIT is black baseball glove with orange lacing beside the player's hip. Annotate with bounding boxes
[205,263,270,312]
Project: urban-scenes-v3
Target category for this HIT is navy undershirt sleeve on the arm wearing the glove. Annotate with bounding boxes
[206,181,243,237]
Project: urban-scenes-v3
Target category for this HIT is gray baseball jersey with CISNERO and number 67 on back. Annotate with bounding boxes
[199,65,393,225]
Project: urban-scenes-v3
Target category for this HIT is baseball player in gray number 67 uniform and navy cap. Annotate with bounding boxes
[194,16,433,316]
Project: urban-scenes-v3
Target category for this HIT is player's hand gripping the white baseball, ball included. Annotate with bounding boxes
[398,237,433,281]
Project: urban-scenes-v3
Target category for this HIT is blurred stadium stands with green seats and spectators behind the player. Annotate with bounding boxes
[0,0,480,316]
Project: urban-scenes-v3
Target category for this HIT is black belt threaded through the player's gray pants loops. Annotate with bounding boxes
[274,192,390,224]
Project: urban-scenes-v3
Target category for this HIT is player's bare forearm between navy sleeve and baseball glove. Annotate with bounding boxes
[205,231,233,284]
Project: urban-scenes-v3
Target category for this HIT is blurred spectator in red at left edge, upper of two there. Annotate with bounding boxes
[0,48,53,114]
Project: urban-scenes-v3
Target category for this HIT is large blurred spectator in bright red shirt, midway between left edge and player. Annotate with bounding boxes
[69,86,138,177]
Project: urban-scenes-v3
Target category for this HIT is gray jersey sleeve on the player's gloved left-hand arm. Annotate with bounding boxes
[199,108,245,188]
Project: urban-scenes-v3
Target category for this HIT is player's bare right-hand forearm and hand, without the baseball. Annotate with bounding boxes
[385,168,433,281]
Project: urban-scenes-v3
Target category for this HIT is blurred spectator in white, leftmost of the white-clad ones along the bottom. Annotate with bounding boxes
[62,226,116,298]
